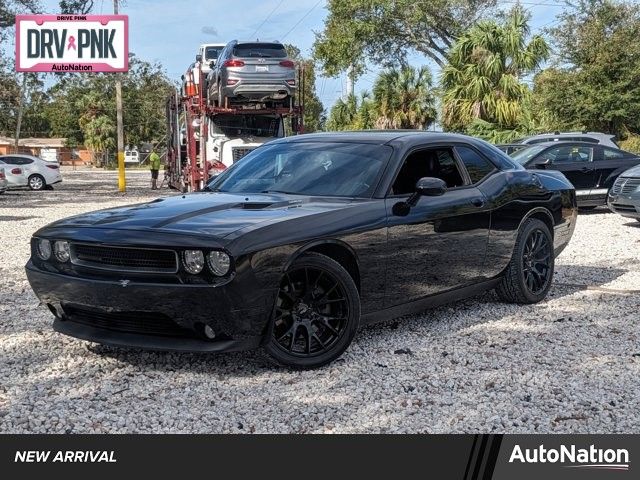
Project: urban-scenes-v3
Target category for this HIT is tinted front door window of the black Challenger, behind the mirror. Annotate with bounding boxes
[391,148,464,195]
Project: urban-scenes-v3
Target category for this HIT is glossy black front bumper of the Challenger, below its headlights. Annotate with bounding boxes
[26,261,275,352]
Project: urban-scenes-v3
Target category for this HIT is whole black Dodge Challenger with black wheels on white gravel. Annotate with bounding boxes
[26,131,577,368]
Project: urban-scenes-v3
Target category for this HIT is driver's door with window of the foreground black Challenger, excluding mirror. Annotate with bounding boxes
[385,145,490,308]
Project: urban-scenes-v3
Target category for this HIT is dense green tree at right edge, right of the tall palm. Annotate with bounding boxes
[534,0,640,137]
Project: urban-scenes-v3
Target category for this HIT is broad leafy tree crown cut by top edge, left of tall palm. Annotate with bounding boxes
[314,0,496,76]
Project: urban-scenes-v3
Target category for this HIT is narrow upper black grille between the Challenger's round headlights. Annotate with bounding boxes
[71,244,178,273]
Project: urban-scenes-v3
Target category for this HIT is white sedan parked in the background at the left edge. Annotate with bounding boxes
[0,153,62,190]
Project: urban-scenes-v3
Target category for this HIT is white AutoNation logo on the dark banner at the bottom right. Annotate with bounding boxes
[509,445,629,470]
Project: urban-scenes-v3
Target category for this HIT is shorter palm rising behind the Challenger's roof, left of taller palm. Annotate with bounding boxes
[373,66,436,130]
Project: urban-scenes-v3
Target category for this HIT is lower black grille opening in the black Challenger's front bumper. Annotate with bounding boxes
[63,305,196,338]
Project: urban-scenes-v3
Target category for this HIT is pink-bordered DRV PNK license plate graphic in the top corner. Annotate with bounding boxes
[16,15,129,72]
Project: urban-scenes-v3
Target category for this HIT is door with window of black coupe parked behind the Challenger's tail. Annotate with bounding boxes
[529,144,597,196]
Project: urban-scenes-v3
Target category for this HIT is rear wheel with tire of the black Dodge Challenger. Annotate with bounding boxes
[496,218,555,303]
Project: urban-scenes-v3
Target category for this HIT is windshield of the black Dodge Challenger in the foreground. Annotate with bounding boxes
[208,142,393,198]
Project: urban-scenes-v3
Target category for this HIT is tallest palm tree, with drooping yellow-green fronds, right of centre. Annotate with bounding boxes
[441,5,549,131]
